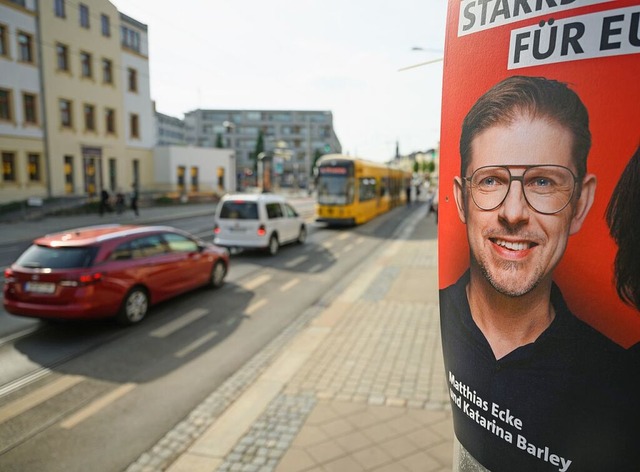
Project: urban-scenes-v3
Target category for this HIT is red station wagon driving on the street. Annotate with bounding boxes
[3,225,229,325]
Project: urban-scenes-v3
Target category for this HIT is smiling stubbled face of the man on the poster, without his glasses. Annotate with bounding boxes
[454,115,595,297]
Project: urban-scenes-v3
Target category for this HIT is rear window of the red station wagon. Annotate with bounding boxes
[16,244,98,269]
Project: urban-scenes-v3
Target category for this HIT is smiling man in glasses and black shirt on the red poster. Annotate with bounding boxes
[440,76,640,472]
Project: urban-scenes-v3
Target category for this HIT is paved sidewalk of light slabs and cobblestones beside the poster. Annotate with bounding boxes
[127,204,453,472]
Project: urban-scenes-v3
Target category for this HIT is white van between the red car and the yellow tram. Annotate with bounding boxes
[213,193,307,255]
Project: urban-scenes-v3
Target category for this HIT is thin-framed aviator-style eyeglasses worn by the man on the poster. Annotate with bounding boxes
[464,165,578,215]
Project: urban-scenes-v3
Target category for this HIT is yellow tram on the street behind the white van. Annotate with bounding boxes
[316,154,411,225]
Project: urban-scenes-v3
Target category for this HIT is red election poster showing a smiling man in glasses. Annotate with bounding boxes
[438,0,640,472]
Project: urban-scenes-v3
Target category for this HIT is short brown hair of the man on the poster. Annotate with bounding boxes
[460,76,591,182]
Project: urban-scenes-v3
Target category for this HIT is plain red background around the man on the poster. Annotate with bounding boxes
[438,0,640,347]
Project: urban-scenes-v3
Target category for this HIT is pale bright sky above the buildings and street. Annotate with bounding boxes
[111,0,447,161]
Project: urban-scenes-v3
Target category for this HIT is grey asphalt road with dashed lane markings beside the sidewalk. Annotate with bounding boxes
[0,204,418,472]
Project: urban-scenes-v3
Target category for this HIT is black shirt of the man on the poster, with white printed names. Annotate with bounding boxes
[440,272,640,472]
